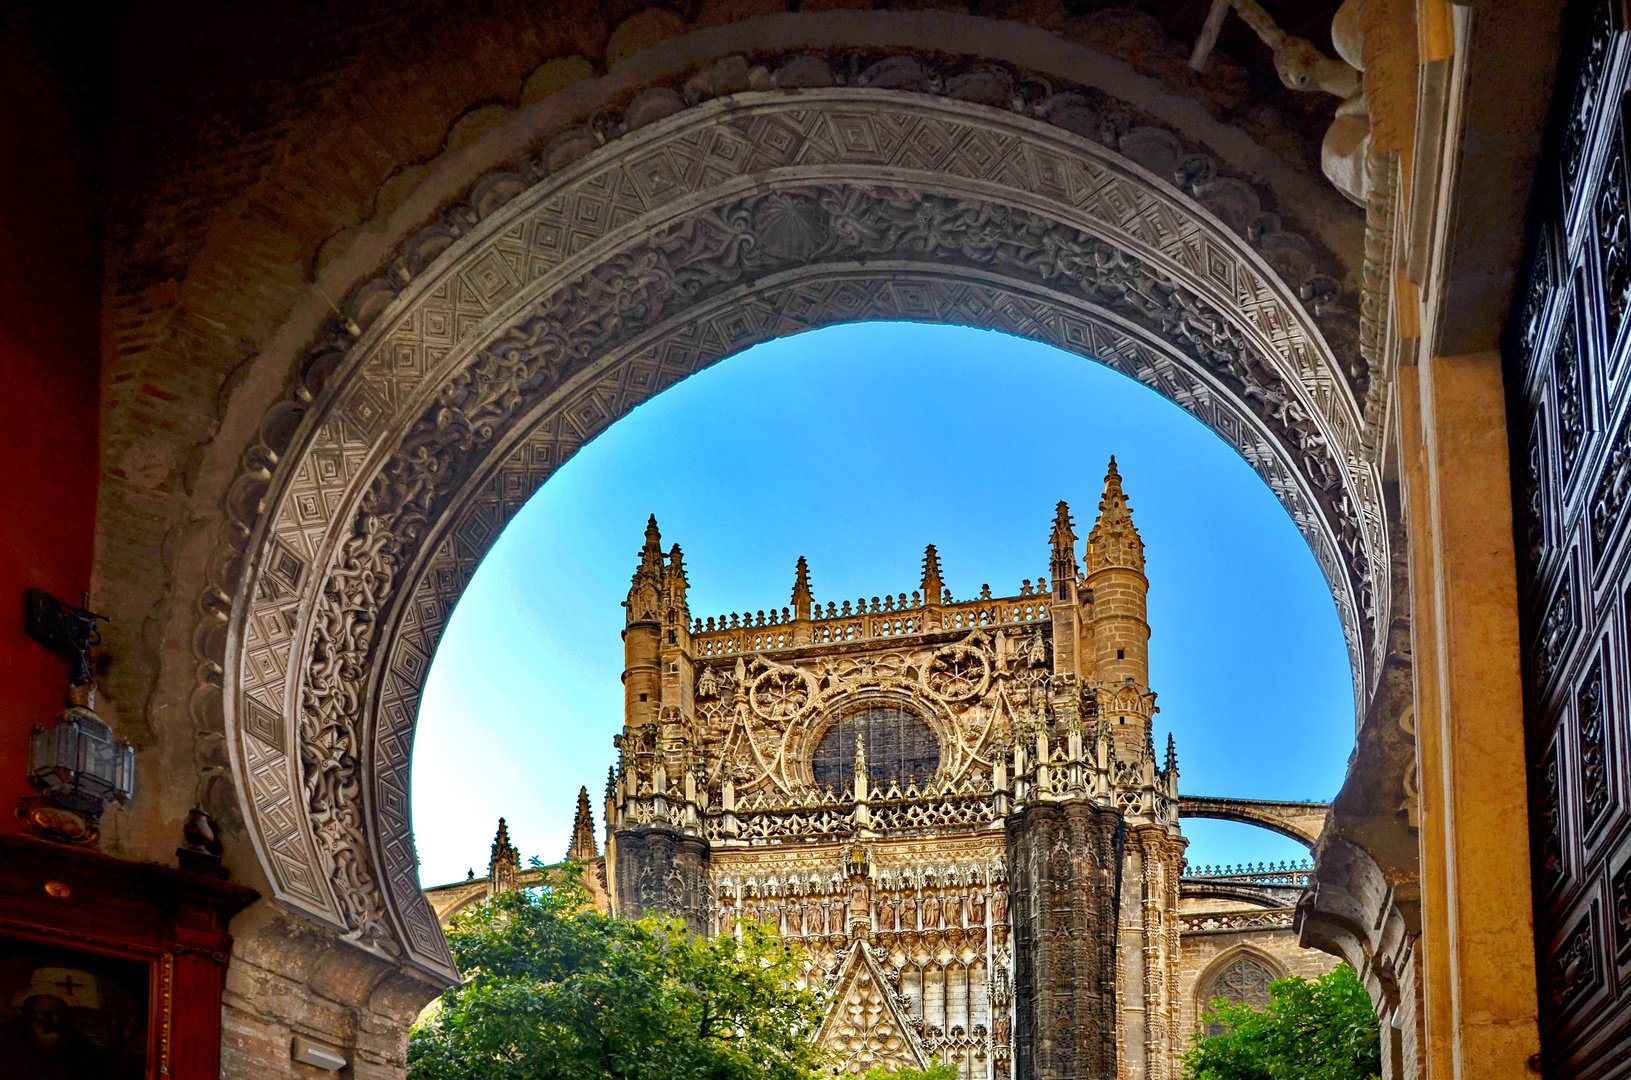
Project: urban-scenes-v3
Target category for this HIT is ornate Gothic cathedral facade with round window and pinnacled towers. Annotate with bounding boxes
[605,460,1333,1080]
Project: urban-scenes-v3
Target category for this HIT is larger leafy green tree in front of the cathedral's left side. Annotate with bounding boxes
[408,871,827,1080]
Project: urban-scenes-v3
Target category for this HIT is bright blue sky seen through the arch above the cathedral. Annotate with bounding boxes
[413,323,1354,884]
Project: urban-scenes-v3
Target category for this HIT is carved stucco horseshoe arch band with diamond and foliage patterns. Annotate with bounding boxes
[216,88,1386,977]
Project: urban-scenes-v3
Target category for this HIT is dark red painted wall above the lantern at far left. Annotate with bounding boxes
[0,2,106,832]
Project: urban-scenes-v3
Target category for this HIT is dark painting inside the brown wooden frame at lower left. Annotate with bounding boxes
[0,938,152,1080]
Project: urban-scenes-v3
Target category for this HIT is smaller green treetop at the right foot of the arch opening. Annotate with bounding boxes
[1184,964,1381,1080]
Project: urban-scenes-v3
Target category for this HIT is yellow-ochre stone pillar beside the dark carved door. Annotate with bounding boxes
[1399,351,1540,1080]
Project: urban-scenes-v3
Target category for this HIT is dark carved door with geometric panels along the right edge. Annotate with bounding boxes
[1505,0,1631,1080]
